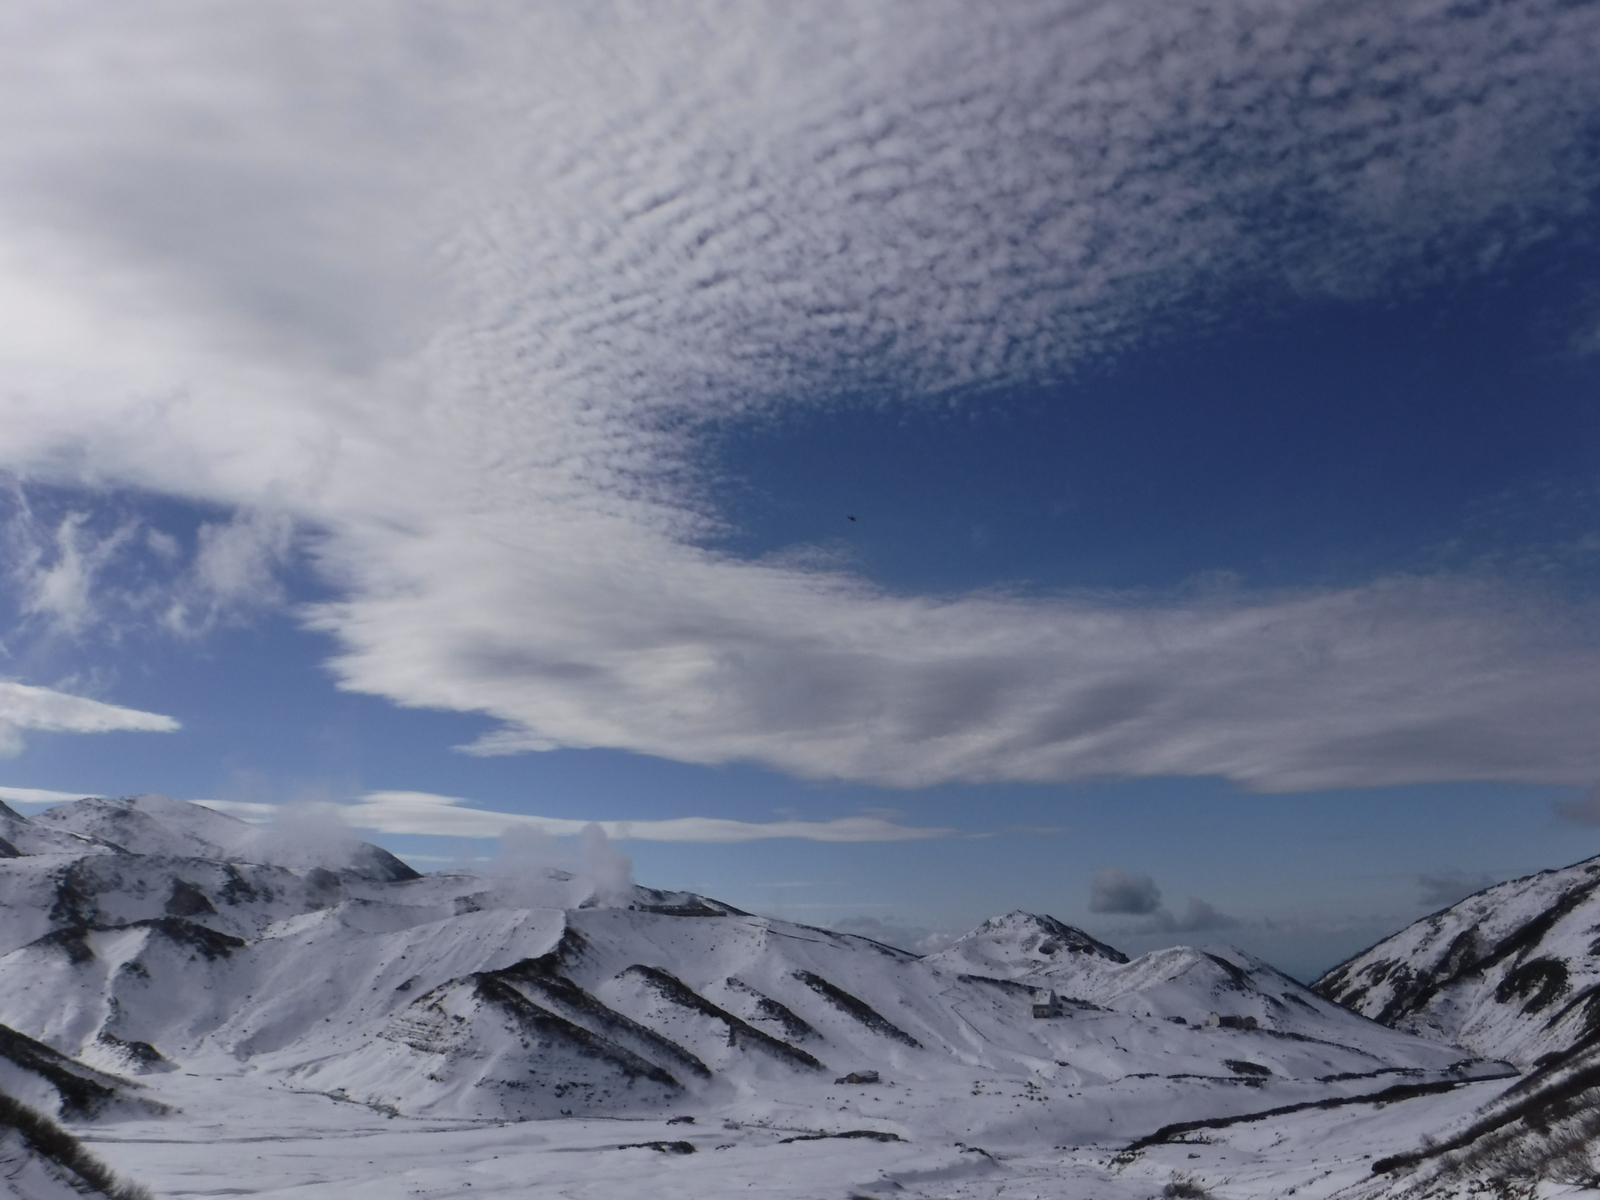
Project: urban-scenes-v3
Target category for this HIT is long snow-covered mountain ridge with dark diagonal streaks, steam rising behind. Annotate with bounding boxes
[0,797,1497,1139]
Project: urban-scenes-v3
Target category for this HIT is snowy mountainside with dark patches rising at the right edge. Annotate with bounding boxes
[1312,858,1600,1066]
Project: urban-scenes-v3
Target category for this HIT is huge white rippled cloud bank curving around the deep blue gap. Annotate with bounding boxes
[0,0,1600,789]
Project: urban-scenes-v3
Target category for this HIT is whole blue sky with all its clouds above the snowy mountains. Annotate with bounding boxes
[0,0,1600,978]
